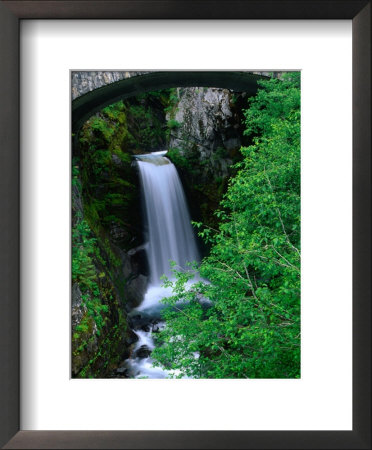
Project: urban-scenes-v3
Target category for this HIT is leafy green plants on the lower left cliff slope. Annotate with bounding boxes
[72,163,127,378]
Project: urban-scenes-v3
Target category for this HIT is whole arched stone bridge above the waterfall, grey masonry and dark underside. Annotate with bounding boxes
[71,71,268,133]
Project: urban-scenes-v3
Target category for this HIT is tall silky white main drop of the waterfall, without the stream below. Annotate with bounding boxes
[137,152,199,286]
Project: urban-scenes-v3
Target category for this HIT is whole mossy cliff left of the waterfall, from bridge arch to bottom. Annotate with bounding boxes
[71,93,169,378]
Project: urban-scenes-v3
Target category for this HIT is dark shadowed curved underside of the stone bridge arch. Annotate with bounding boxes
[72,71,265,133]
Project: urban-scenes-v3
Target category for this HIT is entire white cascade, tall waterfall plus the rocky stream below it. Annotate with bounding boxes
[127,151,199,378]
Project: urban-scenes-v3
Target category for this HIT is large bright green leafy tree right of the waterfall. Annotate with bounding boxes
[152,73,300,378]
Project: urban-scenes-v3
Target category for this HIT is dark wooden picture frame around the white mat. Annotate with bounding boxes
[0,0,371,449]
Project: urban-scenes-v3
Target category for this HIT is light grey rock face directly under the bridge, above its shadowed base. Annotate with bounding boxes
[167,87,241,177]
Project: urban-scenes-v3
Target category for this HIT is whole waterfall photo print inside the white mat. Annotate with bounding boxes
[71,71,301,379]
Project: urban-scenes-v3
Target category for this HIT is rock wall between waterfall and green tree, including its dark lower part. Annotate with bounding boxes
[163,87,253,239]
